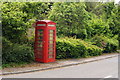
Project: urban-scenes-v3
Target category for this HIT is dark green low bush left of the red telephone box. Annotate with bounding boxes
[2,38,33,64]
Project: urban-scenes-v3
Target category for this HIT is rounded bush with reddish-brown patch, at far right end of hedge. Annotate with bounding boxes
[91,35,119,53]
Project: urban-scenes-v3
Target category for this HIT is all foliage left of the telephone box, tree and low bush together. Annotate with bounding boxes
[1,2,50,64]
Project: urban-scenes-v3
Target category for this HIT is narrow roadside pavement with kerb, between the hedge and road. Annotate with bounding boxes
[0,53,119,75]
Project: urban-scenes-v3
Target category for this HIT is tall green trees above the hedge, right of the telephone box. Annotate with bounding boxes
[49,3,120,39]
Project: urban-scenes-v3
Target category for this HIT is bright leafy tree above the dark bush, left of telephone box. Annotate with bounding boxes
[1,2,52,43]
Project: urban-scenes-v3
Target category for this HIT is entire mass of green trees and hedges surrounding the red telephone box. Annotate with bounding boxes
[1,2,120,63]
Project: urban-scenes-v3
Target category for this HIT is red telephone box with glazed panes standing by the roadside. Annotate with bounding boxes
[34,20,56,63]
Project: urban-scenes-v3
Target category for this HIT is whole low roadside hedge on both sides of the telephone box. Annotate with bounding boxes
[2,36,118,64]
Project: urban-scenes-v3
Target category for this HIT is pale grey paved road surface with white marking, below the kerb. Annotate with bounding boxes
[2,57,118,78]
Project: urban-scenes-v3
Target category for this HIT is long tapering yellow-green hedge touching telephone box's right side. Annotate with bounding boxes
[57,38,102,59]
